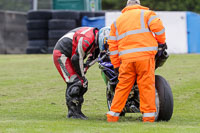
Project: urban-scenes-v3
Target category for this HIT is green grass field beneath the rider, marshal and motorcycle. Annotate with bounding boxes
[0,54,200,133]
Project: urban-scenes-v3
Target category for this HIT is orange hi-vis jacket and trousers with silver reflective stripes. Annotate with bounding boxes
[107,5,165,122]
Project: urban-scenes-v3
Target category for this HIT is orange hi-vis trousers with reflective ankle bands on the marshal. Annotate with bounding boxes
[107,58,156,122]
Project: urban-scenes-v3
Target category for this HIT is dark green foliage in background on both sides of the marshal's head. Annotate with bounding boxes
[102,0,200,13]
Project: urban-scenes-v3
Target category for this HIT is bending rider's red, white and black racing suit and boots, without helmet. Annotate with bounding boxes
[53,27,99,119]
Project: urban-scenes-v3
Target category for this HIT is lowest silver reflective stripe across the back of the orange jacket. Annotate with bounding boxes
[119,47,158,56]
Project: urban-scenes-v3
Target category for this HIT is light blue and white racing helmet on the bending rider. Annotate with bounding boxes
[98,27,110,51]
